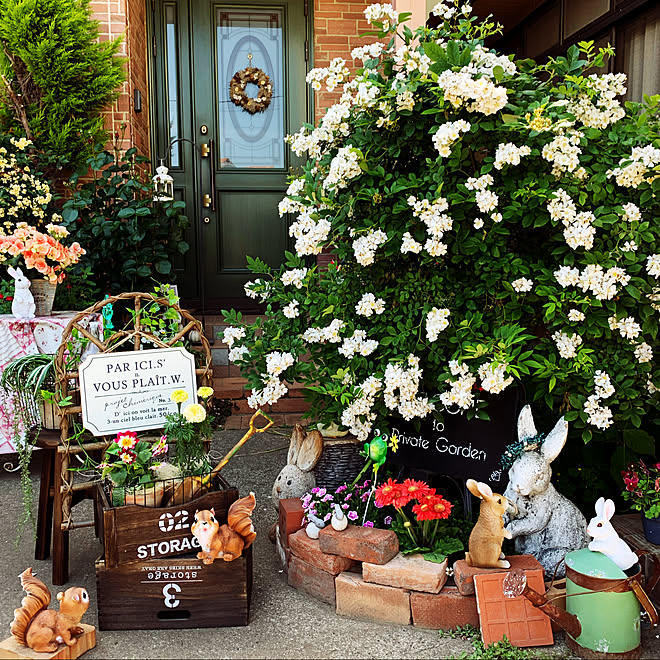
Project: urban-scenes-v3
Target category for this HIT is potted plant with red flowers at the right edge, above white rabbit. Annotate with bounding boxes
[621,459,660,545]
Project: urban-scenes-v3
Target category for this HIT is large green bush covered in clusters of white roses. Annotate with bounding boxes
[224,2,660,442]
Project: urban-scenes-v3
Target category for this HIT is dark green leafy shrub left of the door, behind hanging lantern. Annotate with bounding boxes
[62,149,189,295]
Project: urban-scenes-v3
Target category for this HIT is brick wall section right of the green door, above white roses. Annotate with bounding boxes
[314,0,374,121]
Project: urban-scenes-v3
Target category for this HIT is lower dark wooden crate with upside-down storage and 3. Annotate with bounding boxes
[96,547,252,630]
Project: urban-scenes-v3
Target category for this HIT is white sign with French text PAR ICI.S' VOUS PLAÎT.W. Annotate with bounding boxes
[79,347,197,435]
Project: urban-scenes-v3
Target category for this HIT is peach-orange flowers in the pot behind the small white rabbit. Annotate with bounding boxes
[0,222,85,282]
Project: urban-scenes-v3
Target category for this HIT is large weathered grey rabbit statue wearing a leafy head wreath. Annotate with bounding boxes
[504,406,589,577]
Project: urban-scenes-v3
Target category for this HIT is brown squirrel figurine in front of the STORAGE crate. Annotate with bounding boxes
[190,493,257,564]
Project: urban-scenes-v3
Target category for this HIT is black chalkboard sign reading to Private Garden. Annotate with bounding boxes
[387,388,523,493]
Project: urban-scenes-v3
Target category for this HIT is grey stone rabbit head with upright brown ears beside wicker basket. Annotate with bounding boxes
[272,424,323,511]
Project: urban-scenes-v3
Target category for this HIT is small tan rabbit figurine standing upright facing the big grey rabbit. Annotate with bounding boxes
[465,479,511,568]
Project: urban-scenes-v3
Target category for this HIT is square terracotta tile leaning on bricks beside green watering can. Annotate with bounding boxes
[474,569,554,646]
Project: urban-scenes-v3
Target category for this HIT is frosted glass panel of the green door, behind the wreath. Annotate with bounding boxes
[216,7,285,169]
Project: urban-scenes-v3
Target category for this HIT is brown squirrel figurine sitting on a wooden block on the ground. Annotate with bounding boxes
[10,568,89,653]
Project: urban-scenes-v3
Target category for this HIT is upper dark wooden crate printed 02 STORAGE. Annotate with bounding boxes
[96,478,238,568]
